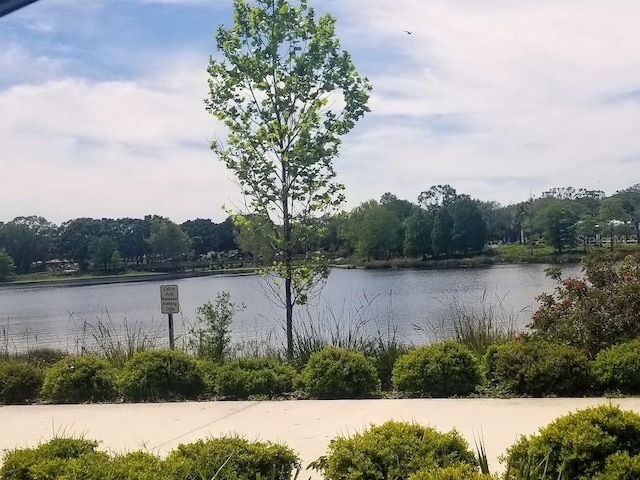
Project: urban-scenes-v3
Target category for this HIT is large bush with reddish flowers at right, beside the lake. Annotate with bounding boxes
[529,254,640,357]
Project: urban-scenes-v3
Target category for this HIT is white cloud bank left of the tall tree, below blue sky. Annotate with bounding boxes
[0,56,237,223]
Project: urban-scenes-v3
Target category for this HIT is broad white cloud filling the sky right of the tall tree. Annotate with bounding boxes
[324,0,640,206]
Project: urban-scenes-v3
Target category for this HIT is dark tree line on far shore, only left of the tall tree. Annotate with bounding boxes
[0,215,237,273]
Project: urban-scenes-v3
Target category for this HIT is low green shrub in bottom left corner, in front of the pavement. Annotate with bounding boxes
[0,437,104,480]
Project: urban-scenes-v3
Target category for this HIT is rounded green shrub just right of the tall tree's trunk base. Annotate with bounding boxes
[299,347,380,399]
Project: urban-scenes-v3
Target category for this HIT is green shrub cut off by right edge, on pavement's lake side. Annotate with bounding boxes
[592,339,640,394]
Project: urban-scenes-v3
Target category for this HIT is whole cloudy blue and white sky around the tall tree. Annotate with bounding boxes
[0,0,640,224]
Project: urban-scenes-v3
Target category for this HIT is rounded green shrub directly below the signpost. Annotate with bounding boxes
[118,350,206,401]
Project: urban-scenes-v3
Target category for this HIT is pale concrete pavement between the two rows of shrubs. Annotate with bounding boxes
[0,398,640,480]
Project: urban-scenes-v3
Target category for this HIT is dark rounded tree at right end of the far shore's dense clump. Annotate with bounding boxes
[451,195,487,254]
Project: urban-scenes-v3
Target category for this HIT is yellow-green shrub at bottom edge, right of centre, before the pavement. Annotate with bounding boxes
[312,421,476,480]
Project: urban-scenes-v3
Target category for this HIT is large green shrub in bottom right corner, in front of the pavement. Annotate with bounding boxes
[503,405,640,480]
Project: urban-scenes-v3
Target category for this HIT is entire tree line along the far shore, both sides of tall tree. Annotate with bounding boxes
[0,184,640,282]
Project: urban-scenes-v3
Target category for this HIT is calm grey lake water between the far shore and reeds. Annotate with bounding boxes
[0,265,580,351]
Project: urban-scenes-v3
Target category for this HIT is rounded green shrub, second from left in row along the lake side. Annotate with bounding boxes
[42,355,117,403]
